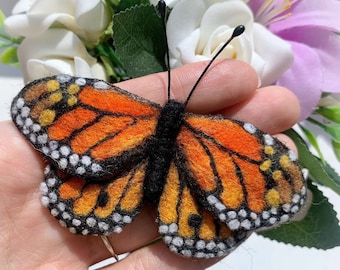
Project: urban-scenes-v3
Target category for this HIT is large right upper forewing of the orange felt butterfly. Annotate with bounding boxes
[177,114,306,231]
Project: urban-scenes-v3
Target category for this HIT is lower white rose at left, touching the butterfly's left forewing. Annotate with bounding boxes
[18,29,106,83]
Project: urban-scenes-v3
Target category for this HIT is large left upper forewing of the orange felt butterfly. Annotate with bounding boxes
[12,75,160,179]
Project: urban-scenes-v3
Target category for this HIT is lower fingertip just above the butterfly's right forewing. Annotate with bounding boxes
[218,86,300,134]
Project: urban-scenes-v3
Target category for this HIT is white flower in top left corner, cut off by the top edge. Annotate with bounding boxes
[5,0,111,42]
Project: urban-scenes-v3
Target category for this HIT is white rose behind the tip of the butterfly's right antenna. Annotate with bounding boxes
[167,0,293,85]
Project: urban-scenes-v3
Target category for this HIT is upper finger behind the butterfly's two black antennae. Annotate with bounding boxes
[117,60,258,113]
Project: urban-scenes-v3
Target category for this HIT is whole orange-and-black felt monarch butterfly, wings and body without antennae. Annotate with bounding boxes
[11,75,306,258]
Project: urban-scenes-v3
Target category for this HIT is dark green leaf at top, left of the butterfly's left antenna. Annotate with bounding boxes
[113,6,166,78]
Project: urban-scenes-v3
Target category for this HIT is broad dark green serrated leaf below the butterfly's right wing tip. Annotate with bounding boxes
[259,181,340,249]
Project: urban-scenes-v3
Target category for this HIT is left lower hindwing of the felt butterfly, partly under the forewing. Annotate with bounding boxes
[40,163,146,235]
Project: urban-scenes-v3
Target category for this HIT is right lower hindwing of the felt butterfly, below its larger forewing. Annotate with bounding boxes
[158,160,250,258]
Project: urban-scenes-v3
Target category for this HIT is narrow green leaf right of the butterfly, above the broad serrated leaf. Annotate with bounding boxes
[285,129,340,195]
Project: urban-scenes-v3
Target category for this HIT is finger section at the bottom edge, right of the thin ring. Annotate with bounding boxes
[107,242,218,270]
